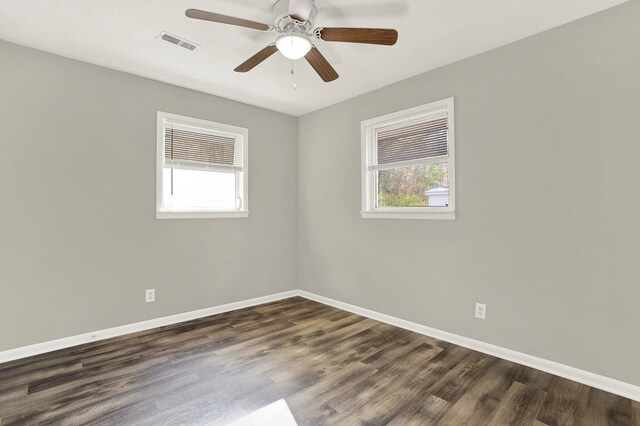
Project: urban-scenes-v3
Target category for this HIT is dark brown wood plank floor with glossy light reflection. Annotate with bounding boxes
[0,298,640,425]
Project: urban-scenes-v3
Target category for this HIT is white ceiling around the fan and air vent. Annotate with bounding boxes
[0,0,626,116]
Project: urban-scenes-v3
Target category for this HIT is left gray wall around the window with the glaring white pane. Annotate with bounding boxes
[0,42,297,350]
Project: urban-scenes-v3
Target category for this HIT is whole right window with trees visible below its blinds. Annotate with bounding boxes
[362,98,455,219]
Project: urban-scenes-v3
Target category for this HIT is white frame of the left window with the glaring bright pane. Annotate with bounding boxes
[156,111,249,219]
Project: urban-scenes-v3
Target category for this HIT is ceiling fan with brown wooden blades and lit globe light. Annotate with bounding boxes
[185,0,398,82]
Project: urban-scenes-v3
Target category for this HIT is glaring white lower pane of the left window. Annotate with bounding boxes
[162,167,237,210]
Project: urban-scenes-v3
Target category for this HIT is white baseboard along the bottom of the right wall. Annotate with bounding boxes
[298,290,640,402]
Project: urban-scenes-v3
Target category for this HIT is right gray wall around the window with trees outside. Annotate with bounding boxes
[298,1,640,385]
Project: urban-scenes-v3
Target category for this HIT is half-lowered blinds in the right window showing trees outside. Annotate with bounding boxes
[376,115,449,164]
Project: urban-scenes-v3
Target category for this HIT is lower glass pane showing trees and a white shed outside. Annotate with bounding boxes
[377,163,449,207]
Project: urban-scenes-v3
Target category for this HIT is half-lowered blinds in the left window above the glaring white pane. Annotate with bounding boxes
[164,125,242,169]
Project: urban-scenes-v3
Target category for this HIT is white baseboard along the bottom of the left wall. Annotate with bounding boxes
[0,290,298,364]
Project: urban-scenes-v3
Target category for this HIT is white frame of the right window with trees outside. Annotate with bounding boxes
[361,97,456,220]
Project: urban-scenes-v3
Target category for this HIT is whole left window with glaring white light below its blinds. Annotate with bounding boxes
[156,112,249,219]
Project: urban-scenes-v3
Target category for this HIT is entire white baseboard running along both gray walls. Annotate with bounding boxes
[0,290,640,401]
